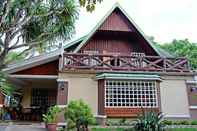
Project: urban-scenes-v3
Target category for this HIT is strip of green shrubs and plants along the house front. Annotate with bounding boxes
[43,100,197,131]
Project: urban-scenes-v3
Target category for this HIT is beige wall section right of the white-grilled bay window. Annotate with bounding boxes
[160,76,192,118]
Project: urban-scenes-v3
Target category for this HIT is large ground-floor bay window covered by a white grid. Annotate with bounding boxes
[105,80,158,108]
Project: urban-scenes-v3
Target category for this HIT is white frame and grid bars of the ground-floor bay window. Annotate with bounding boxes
[104,80,159,108]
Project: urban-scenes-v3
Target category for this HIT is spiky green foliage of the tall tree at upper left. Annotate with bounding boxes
[1,0,78,41]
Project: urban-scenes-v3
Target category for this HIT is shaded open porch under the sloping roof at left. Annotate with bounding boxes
[3,75,66,122]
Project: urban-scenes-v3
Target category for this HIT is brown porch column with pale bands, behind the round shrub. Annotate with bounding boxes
[57,79,68,126]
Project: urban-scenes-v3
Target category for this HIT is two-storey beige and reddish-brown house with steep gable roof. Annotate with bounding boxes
[1,4,197,124]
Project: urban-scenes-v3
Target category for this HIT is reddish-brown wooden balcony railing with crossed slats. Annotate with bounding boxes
[61,53,190,72]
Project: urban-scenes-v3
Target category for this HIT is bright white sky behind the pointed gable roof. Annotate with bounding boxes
[74,0,197,43]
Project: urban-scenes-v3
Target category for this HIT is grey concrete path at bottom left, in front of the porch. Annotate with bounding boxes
[0,125,47,131]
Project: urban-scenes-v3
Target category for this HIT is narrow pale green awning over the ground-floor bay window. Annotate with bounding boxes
[96,73,161,81]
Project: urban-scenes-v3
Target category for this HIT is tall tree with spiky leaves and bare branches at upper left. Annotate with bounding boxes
[0,0,78,70]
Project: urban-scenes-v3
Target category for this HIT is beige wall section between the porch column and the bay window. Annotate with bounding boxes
[59,73,98,115]
